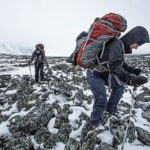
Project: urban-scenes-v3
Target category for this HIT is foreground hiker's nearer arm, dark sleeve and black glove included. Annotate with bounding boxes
[108,40,148,86]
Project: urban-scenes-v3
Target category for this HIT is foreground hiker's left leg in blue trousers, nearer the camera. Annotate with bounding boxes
[87,70,107,125]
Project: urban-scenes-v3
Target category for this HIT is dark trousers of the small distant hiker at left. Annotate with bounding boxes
[35,63,44,83]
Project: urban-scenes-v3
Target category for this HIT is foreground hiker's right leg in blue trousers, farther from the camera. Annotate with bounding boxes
[106,78,125,113]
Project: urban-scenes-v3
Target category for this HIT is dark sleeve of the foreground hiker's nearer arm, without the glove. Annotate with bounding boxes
[108,40,130,82]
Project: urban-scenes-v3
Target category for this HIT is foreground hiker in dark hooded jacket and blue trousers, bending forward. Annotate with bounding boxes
[87,26,150,127]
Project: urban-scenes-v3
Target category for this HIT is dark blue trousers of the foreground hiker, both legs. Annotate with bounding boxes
[87,70,124,125]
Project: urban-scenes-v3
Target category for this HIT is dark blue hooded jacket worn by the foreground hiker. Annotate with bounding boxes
[93,26,149,83]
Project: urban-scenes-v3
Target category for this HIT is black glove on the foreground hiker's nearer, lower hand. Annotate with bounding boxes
[127,76,148,86]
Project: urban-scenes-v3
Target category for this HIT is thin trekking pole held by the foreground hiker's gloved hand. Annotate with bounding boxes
[121,86,137,150]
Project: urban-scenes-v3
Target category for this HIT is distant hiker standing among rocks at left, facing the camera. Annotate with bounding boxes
[29,43,48,83]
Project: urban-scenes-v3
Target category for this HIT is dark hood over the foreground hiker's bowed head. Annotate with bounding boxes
[121,26,150,54]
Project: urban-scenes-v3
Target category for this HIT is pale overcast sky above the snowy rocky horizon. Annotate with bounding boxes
[0,0,150,56]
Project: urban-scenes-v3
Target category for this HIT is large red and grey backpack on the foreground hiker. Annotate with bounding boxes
[68,13,127,68]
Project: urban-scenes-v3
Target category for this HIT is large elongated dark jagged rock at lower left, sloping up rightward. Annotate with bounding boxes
[10,104,54,133]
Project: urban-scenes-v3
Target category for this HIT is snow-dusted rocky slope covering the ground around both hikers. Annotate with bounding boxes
[0,55,150,150]
